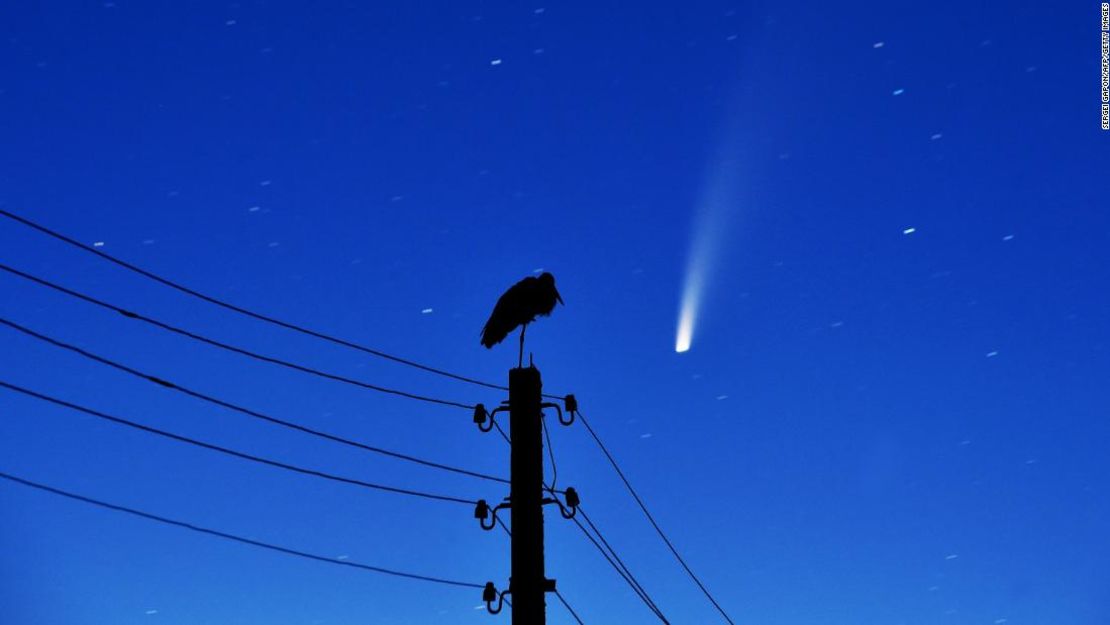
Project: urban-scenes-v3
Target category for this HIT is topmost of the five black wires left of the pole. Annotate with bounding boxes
[0,209,508,391]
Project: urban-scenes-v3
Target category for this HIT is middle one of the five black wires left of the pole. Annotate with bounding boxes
[0,317,508,484]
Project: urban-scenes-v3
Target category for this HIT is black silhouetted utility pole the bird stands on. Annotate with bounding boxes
[508,366,554,625]
